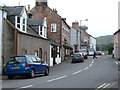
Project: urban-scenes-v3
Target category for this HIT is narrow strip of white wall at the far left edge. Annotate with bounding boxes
[0,10,3,73]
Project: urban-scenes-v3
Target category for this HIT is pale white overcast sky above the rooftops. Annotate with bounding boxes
[0,0,120,37]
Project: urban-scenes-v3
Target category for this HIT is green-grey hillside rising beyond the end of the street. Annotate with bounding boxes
[97,35,113,46]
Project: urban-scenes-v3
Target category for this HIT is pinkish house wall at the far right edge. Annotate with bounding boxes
[114,29,120,60]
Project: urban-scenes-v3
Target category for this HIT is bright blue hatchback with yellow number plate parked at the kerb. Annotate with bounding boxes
[4,55,49,79]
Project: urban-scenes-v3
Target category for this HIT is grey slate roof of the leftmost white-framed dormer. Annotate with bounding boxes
[3,6,24,15]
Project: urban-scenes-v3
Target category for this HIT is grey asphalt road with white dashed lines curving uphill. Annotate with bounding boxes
[2,56,118,90]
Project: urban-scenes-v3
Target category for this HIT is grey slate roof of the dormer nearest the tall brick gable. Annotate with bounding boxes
[28,18,44,26]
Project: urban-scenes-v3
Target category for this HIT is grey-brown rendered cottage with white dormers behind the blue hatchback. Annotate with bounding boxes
[3,6,50,66]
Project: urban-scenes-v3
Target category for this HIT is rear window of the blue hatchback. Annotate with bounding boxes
[7,57,26,64]
